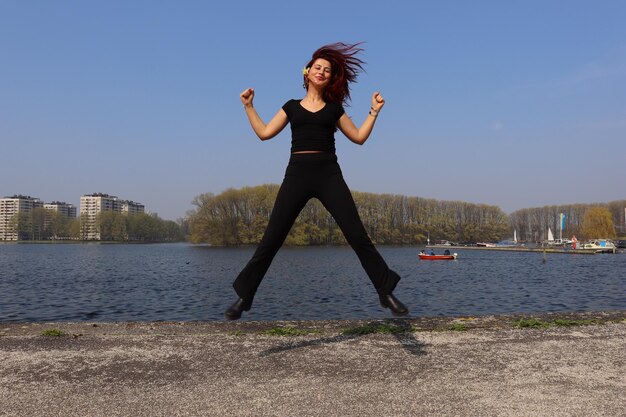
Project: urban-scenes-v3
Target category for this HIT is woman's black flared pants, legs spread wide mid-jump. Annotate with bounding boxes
[233,153,400,300]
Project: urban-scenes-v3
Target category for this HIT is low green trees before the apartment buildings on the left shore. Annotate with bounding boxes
[10,208,185,242]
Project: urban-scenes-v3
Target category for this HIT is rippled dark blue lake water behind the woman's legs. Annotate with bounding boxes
[0,244,626,322]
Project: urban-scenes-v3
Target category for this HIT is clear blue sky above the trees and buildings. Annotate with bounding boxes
[0,0,626,220]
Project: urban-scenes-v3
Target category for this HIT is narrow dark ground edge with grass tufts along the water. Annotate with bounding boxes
[0,310,626,338]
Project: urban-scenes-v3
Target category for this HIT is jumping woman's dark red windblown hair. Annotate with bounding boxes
[304,42,365,105]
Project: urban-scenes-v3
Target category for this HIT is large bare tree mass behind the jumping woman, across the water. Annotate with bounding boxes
[187,184,512,246]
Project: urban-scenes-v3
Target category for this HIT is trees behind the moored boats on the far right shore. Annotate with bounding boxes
[510,200,626,242]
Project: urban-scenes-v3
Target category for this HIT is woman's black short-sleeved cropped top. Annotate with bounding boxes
[283,99,344,153]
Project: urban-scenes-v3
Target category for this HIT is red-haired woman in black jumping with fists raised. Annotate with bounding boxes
[225,43,409,320]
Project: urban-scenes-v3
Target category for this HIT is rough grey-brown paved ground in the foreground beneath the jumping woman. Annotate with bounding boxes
[0,312,626,417]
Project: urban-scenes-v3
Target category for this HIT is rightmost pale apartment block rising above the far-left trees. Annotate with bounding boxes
[80,193,145,240]
